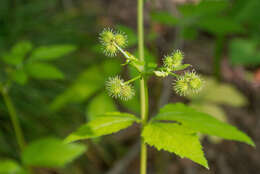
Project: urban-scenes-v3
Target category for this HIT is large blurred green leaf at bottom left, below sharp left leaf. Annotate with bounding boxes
[22,138,86,168]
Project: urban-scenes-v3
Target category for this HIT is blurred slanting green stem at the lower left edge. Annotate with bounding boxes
[1,89,25,152]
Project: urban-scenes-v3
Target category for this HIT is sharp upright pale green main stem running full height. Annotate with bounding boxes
[137,0,148,174]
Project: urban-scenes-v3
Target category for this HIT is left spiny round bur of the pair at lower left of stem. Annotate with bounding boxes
[106,76,124,98]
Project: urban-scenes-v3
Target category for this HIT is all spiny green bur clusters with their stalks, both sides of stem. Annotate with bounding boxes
[100,29,203,100]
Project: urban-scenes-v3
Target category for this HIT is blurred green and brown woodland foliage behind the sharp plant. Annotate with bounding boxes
[0,0,260,174]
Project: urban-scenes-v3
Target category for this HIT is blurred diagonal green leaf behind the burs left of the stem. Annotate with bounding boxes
[50,60,120,111]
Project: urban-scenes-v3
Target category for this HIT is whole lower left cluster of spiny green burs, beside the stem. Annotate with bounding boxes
[106,76,135,100]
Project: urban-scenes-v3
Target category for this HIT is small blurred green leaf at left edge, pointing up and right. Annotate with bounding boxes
[3,41,32,65]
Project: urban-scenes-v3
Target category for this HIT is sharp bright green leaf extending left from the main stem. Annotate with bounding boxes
[65,112,139,143]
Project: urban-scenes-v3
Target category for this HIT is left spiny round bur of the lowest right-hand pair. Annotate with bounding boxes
[173,76,190,96]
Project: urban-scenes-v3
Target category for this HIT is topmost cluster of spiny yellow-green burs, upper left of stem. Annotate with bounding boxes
[99,28,127,57]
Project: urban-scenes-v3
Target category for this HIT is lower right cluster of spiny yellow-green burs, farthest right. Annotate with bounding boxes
[173,71,203,96]
